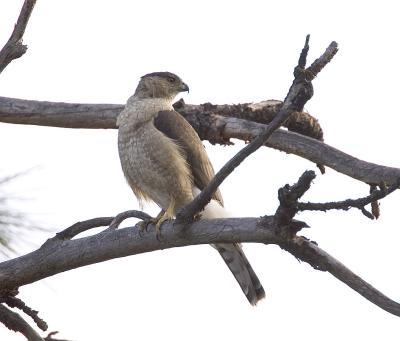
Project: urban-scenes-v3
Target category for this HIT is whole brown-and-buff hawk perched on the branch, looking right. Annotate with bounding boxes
[117,72,265,305]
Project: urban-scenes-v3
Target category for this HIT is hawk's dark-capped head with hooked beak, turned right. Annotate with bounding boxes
[135,72,189,100]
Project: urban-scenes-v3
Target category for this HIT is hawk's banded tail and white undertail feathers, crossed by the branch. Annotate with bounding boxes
[201,195,265,305]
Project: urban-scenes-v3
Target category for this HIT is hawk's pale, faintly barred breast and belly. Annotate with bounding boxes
[118,121,193,209]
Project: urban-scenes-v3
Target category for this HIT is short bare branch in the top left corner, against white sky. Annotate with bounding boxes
[0,0,36,73]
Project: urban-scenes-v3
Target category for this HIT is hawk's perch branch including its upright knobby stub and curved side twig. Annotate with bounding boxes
[0,161,400,316]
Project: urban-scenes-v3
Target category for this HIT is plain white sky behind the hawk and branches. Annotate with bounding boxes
[0,0,400,341]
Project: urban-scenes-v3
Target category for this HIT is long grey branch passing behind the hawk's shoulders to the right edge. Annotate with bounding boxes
[0,97,400,184]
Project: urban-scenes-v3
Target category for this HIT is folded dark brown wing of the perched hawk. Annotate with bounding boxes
[154,110,223,205]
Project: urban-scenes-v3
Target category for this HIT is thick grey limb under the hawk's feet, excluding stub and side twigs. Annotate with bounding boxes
[0,216,400,316]
